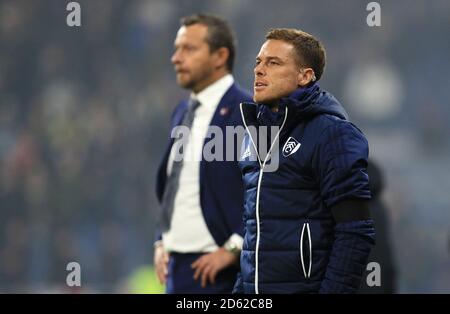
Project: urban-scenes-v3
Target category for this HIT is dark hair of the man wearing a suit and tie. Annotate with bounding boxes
[180,14,236,72]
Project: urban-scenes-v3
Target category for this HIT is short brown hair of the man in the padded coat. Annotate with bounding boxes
[266,28,326,81]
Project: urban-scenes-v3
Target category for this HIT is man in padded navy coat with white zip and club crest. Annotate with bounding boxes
[234,29,375,293]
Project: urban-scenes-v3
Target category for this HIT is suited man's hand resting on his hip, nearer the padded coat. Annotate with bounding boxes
[191,248,238,288]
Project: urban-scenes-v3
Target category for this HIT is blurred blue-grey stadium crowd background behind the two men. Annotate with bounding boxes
[0,0,450,293]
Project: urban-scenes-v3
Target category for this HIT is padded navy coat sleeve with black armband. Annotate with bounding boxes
[315,121,375,293]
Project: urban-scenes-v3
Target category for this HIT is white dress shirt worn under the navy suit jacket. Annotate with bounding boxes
[162,74,234,253]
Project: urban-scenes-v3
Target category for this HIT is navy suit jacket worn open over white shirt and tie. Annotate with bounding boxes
[156,83,251,246]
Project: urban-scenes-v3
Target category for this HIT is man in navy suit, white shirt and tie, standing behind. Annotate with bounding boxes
[154,15,251,293]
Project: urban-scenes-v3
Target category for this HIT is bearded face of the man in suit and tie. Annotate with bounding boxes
[171,24,214,92]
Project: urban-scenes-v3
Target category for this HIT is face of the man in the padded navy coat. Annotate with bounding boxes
[253,39,300,104]
